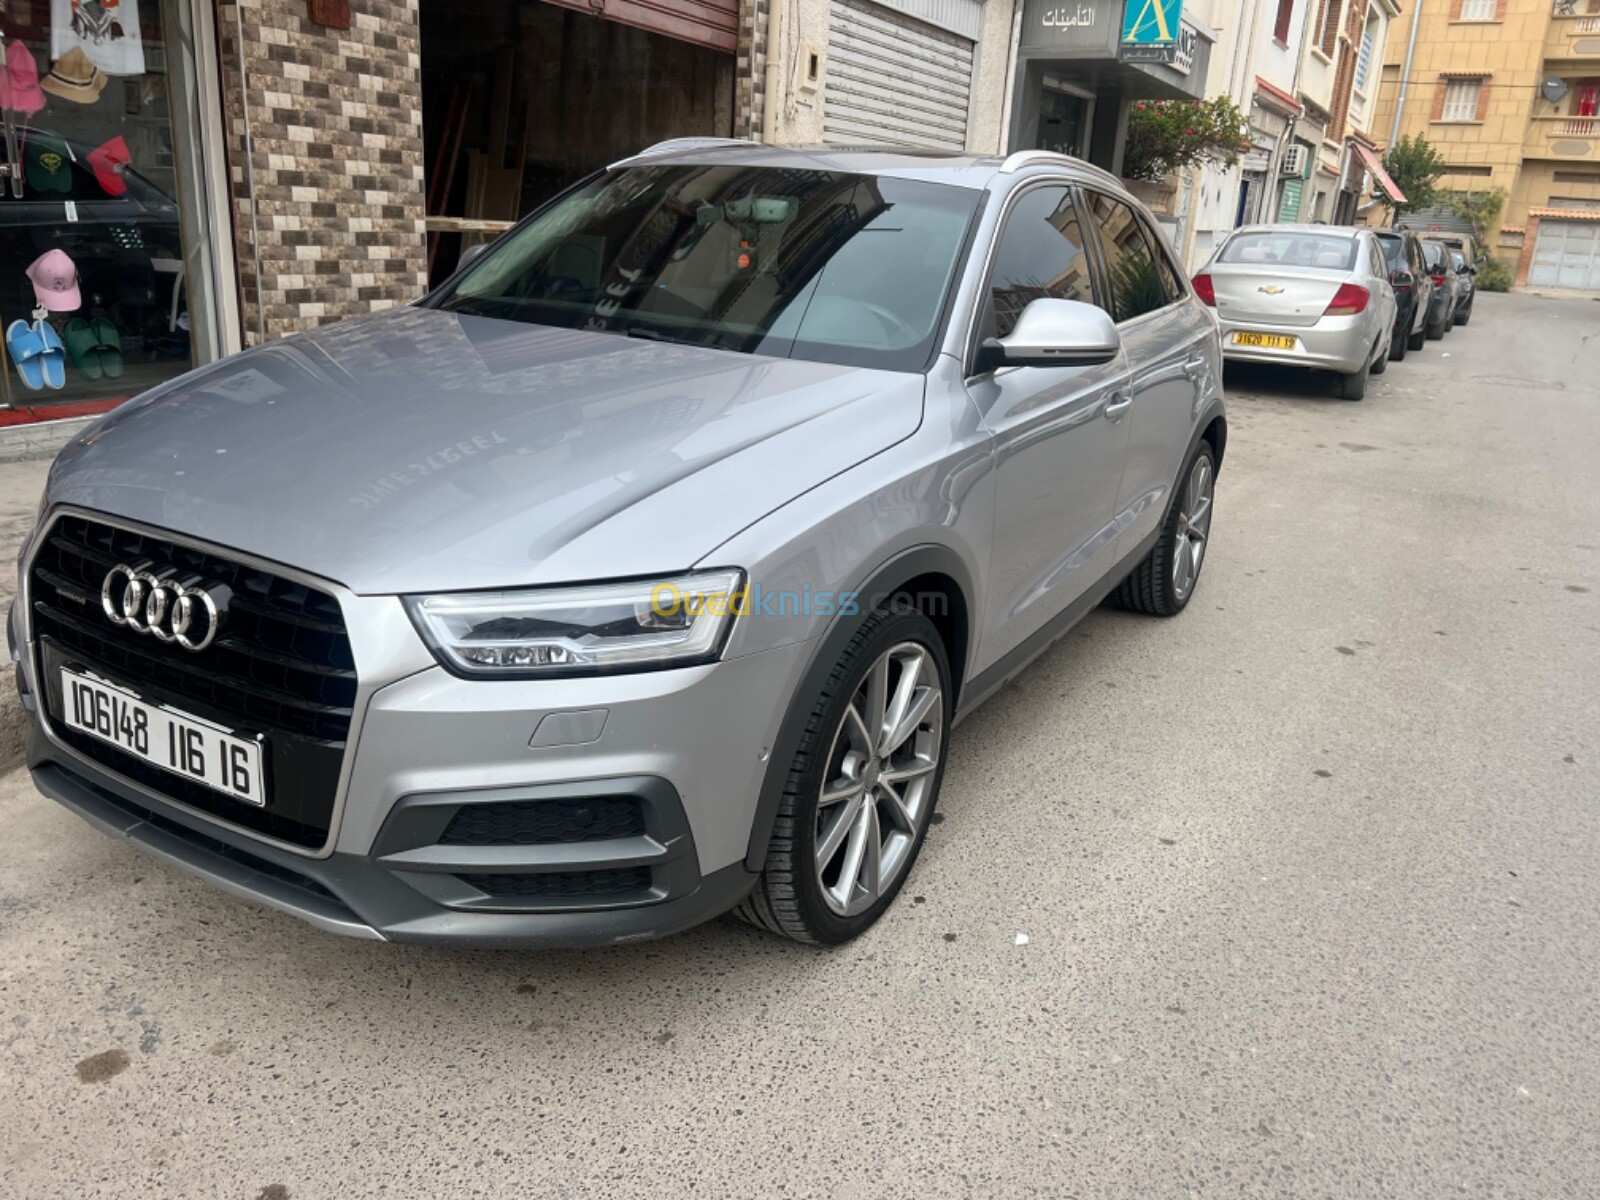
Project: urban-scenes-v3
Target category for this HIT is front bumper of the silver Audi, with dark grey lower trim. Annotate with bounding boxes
[18,602,810,947]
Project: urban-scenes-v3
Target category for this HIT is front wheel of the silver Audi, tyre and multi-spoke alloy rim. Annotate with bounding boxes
[734,605,952,946]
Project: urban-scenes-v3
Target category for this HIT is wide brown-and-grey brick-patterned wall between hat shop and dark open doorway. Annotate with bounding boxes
[216,0,427,346]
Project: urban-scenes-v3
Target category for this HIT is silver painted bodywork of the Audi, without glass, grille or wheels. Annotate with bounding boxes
[13,146,1222,944]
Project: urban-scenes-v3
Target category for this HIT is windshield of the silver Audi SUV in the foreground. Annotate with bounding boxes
[434,166,981,370]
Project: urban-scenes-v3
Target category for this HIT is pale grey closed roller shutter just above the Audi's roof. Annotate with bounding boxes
[822,0,973,150]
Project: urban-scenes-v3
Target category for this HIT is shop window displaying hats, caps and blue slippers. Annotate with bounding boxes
[0,0,238,411]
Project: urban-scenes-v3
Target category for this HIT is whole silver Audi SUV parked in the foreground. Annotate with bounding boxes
[10,139,1227,946]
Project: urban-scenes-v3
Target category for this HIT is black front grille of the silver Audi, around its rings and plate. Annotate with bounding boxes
[29,515,357,848]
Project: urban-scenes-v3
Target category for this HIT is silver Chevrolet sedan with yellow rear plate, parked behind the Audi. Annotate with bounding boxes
[1194,226,1395,400]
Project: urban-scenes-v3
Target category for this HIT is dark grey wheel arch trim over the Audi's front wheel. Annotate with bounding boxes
[744,542,976,870]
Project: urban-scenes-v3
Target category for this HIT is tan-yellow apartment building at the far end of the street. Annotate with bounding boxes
[1376,0,1600,291]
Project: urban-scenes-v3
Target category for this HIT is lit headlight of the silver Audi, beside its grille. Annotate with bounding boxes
[406,571,744,677]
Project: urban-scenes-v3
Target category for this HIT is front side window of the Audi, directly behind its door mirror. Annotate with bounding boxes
[984,187,1094,338]
